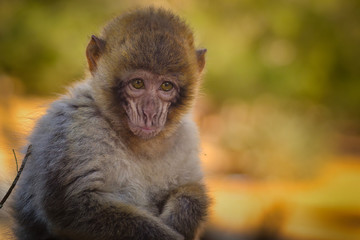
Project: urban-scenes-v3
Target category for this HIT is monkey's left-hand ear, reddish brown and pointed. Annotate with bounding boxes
[86,35,105,75]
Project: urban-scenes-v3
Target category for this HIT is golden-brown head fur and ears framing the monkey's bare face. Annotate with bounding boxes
[87,8,206,145]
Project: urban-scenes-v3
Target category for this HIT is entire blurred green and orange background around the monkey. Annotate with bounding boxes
[0,0,360,240]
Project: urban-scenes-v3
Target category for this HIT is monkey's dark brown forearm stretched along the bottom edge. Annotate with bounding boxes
[44,189,184,240]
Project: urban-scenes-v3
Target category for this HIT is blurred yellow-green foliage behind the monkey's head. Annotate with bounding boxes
[0,0,360,116]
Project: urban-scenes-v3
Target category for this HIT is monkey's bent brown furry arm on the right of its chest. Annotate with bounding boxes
[160,183,209,240]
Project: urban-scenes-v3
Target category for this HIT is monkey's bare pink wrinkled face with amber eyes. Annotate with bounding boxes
[121,70,180,139]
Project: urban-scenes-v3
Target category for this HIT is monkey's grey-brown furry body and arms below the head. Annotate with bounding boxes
[14,81,208,240]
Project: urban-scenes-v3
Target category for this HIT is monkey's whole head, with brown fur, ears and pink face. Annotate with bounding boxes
[86,9,206,141]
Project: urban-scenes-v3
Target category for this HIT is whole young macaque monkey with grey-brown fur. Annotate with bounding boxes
[13,8,209,240]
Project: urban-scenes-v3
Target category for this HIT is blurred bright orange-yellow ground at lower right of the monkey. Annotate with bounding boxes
[207,159,360,240]
